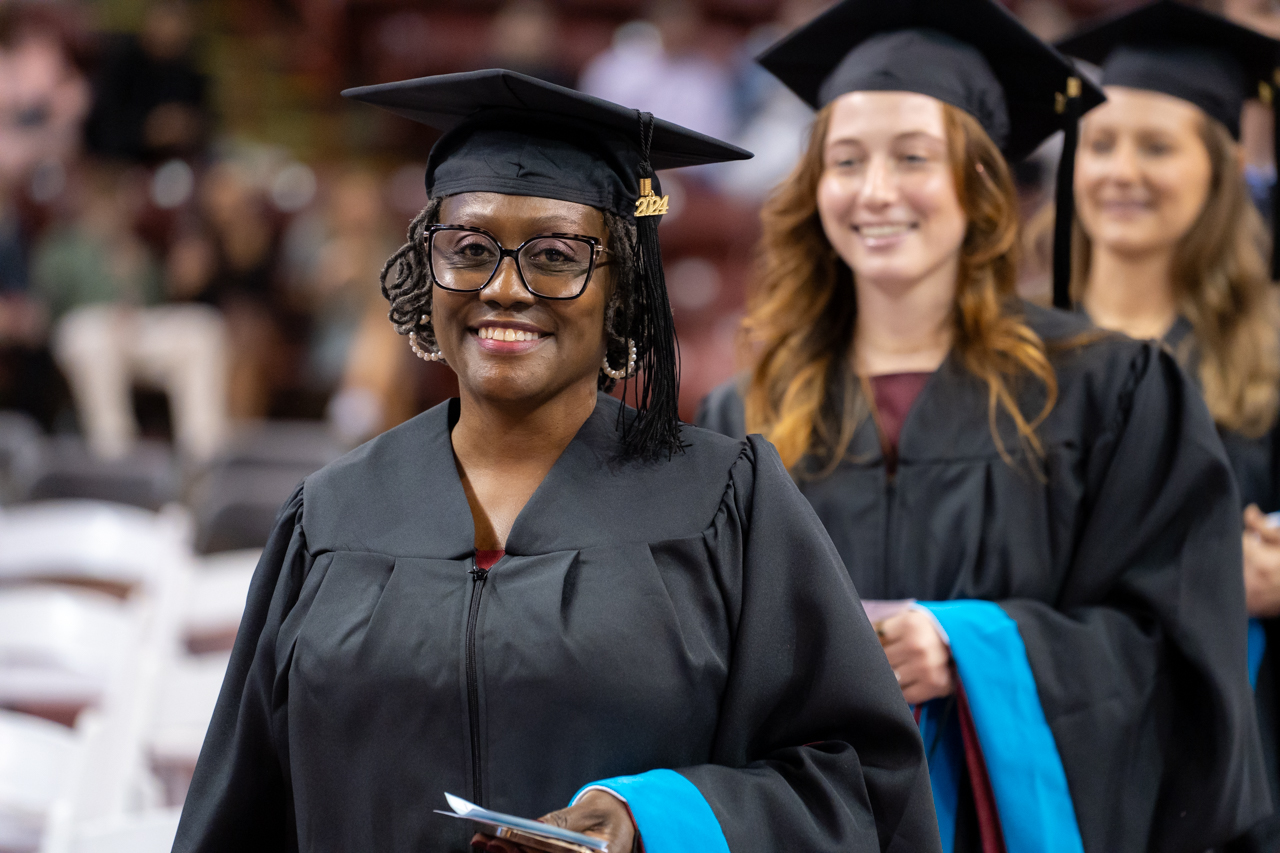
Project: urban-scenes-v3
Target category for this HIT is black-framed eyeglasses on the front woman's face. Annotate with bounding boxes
[426,225,608,300]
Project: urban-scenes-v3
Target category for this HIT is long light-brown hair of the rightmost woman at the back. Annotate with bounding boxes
[1071,115,1280,438]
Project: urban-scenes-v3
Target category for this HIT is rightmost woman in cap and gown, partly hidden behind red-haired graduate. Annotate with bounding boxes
[1060,0,1280,850]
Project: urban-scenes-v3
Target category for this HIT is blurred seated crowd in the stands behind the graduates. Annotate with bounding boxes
[0,0,1280,505]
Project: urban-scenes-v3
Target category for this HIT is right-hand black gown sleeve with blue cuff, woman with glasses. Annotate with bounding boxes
[581,437,941,853]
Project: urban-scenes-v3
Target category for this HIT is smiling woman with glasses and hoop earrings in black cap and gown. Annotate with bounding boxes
[174,70,938,853]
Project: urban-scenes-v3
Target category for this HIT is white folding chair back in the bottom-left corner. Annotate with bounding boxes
[0,711,78,852]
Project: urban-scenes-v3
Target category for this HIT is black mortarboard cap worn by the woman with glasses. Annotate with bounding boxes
[343,69,751,214]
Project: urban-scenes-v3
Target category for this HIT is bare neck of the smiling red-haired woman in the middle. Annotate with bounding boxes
[854,263,957,377]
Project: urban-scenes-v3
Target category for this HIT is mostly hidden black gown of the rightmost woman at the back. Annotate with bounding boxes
[1162,318,1280,853]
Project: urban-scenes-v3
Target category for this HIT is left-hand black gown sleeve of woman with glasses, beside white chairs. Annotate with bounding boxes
[173,485,311,853]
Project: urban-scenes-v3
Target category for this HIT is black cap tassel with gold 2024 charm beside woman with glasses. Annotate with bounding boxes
[626,113,680,452]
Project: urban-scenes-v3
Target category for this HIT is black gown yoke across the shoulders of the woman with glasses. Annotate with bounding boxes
[303,394,745,560]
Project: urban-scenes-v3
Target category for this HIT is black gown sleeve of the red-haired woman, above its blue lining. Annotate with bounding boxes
[1000,347,1270,852]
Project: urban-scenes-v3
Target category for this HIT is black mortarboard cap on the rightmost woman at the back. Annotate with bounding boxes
[1059,0,1280,278]
